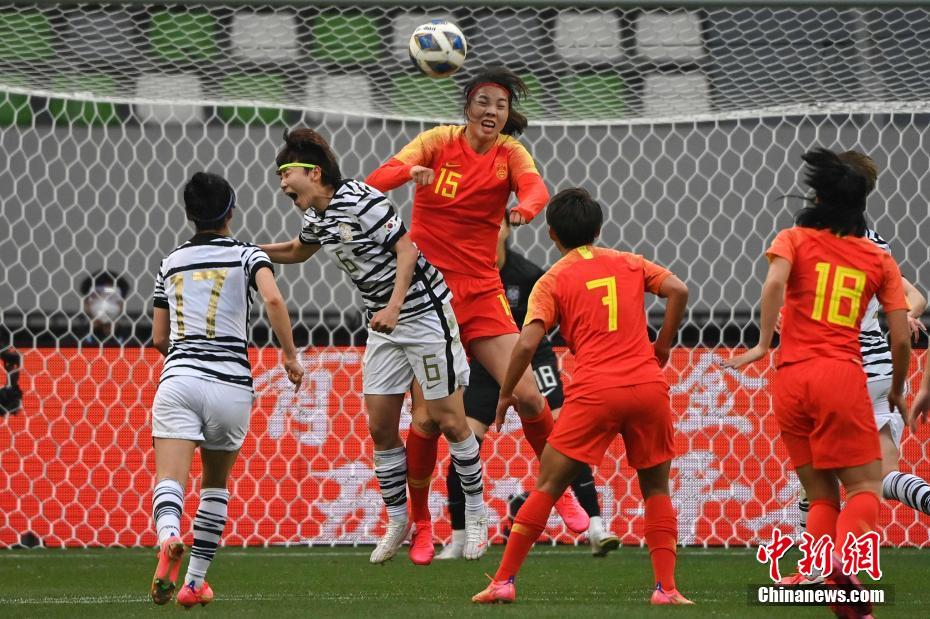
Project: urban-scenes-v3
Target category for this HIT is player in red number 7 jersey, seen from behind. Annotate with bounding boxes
[472,189,690,604]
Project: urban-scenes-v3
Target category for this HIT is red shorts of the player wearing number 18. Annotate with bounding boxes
[774,359,882,469]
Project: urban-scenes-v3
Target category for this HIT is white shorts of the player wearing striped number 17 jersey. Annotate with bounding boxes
[152,376,252,451]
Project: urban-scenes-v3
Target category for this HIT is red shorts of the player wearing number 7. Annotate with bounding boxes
[548,382,675,469]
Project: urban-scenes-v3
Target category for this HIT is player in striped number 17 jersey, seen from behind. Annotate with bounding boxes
[151,172,304,607]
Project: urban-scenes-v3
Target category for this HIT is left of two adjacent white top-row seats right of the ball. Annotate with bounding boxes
[555,11,623,63]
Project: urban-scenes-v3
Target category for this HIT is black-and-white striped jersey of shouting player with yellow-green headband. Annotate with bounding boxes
[300,180,452,321]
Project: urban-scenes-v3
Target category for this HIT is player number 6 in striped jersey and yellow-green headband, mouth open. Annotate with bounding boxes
[254,128,487,563]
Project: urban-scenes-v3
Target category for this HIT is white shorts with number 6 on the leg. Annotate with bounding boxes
[362,303,468,400]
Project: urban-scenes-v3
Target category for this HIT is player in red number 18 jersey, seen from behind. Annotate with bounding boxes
[725,148,910,614]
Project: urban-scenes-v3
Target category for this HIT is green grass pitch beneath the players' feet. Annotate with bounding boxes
[0,547,916,619]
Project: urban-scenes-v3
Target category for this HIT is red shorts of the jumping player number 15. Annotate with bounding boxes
[445,275,520,353]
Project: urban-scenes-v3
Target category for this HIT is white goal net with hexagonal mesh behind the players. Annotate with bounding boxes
[0,0,930,547]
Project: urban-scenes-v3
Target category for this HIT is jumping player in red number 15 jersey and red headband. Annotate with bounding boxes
[365,68,589,564]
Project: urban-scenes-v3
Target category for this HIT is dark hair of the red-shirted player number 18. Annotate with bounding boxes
[795,147,869,236]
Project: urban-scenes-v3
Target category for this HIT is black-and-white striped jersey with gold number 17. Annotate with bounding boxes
[154,234,272,389]
